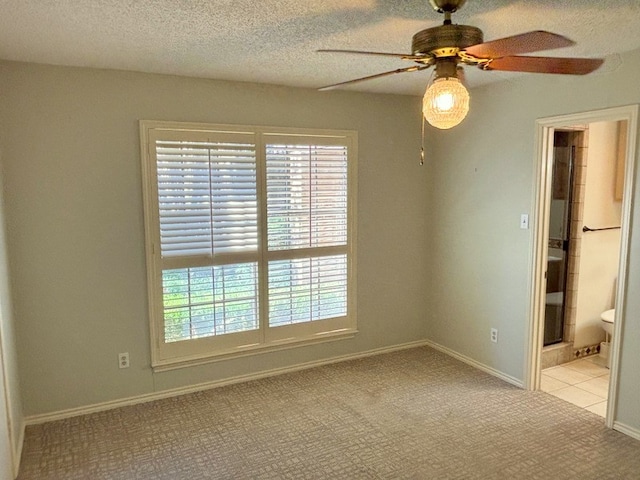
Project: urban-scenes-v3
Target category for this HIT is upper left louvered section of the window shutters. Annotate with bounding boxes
[156,140,258,258]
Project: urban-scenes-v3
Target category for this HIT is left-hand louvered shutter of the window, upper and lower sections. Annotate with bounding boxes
[154,132,259,343]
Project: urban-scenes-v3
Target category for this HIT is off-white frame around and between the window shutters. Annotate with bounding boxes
[140,120,358,371]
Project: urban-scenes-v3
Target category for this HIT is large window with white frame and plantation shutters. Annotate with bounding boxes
[140,121,357,369]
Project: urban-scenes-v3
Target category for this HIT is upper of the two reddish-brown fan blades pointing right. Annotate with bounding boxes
[464,30,575,58]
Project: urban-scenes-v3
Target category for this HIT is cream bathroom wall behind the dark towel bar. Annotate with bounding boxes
[574,122,622,348]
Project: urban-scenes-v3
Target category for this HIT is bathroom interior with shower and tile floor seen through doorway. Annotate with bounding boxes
[541,121,627,417]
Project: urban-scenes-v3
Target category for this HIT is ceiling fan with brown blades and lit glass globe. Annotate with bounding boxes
[318,0,604,129]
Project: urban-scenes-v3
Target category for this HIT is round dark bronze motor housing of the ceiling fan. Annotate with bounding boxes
[411,25,483,57]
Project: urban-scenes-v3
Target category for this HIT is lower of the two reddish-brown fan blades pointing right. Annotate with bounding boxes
[480,56,604,75]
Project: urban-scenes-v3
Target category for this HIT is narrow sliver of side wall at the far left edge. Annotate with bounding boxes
[0,160,23,480]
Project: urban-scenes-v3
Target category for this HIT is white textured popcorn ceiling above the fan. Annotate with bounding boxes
[0,0,640,95]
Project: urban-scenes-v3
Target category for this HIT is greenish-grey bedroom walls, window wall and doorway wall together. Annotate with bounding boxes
[0,46,640,442]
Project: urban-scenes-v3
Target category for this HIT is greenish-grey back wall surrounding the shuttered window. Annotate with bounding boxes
[0,62,433,415]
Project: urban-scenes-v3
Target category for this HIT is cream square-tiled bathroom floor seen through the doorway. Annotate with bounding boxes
[540,355,609,417]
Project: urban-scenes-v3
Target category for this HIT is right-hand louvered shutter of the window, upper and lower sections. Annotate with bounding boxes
[266,139,348,326]
